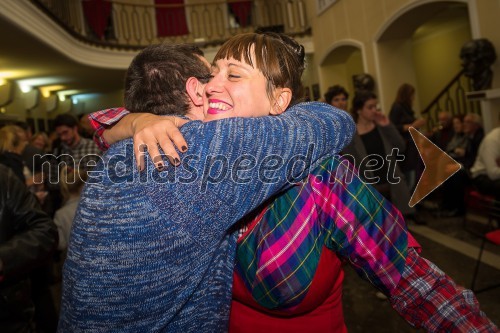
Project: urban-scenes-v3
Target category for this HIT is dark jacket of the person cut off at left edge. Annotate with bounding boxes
[0,165,58,333]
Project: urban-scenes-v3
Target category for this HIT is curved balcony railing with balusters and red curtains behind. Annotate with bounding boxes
[31,0,310,49]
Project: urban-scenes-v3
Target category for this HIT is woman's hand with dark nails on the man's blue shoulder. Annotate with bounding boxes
[132,113,189,171]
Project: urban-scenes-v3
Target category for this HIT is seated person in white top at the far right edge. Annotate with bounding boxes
[470,127,500,200]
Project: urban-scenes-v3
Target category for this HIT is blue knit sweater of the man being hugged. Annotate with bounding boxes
[59,102,355,333]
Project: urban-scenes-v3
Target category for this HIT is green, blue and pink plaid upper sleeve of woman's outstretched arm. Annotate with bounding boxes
[310,158,412,295]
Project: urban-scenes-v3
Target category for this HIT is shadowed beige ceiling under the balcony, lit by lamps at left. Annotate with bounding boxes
[0,15,125,93]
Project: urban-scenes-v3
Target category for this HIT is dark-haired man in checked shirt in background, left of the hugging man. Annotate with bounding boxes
[54,113,100,170]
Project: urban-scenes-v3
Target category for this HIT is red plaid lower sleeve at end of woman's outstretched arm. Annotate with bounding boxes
[390,249,500,333]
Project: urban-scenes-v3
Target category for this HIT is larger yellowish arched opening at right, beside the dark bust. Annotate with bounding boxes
[375,1,472,116]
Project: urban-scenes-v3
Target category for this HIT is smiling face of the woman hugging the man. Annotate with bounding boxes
[205,53,271,121]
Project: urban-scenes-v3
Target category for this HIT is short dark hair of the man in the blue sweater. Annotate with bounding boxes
[124,44,210,115]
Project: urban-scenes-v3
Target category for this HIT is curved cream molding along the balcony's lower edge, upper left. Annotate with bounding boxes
[0,0,137,69]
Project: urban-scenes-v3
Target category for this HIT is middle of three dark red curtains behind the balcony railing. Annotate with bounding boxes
[155,0,189,37]
